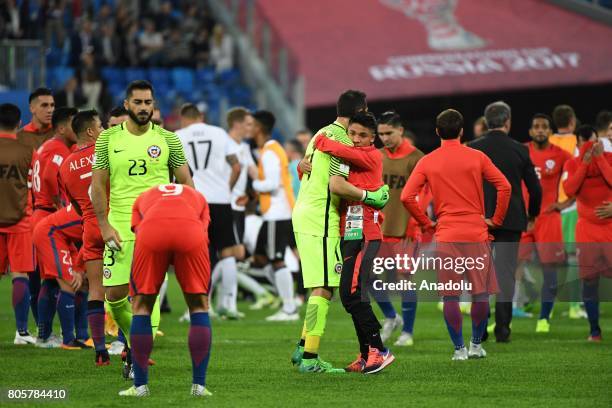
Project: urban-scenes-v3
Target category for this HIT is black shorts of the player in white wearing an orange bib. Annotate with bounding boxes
[255,220,296,261]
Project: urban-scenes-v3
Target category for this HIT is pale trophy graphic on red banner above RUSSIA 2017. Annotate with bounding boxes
[380,0,486,51]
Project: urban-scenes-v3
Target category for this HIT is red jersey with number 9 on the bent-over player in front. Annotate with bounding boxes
[132,184,210,231]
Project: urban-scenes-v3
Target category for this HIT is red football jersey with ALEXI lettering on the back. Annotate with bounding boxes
[60,144,96,221]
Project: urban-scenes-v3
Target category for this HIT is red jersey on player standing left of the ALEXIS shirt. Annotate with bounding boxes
[32,138,70,208]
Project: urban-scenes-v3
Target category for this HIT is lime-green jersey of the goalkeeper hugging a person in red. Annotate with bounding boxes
[292,122,353,237]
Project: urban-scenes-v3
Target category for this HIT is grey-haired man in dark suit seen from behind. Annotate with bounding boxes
[469,101,542,343]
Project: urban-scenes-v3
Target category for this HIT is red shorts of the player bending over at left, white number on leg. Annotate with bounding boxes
[33,211,82,282]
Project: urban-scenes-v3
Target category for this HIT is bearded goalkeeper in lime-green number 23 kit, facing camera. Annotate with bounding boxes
[91,81,193,378]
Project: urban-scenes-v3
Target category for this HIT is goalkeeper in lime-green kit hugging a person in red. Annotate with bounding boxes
[291,90,389,373]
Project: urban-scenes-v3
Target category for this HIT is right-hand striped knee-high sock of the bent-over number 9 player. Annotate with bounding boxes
[189,312,212,386]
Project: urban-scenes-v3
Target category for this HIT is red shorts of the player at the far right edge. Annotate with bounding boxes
[576,218,612,280]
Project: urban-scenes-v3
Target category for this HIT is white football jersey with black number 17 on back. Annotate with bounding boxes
[176,123,238,204]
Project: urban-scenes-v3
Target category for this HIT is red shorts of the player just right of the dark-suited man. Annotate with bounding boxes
[519,211,565,264]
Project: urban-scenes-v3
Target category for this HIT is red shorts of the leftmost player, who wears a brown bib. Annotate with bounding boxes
[0,231,34,275]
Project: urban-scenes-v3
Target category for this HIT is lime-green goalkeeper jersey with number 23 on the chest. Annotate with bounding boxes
[93,122,187,241]
